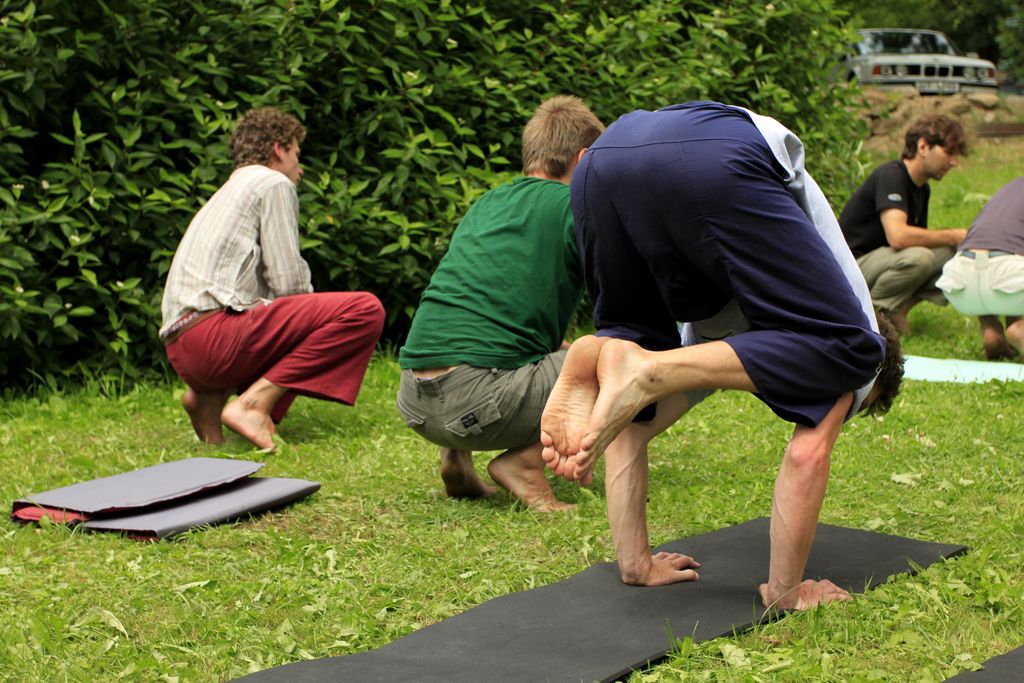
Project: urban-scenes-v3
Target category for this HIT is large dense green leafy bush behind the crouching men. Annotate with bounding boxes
[0,0,861,385]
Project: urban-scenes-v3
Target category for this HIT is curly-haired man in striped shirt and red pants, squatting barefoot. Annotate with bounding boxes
[160,108,384,450]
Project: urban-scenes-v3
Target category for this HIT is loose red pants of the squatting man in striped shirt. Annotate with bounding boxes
[167,292,384,422]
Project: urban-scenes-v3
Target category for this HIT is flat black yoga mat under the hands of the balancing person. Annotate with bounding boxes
[240,517,967,683]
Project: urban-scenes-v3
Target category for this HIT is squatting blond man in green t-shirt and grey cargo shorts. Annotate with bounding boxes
[397,95,604,511]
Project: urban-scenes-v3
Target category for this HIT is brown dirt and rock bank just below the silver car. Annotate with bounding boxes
[861,87,1024,153]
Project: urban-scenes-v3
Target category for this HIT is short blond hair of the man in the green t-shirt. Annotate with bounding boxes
[522,95,604,178]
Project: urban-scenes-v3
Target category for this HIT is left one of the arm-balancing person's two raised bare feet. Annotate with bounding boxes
[541,335,609,476]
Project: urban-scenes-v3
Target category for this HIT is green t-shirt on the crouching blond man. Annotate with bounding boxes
[398,177,583,369]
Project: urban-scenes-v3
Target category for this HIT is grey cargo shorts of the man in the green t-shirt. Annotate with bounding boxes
[396,349,566,451]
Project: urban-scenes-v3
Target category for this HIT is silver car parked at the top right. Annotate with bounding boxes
[845,29,997,95]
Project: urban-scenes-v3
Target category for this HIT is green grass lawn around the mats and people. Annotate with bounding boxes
[0,140,1024,683]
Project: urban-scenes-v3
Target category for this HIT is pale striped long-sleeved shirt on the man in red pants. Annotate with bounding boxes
[160,164,313,337]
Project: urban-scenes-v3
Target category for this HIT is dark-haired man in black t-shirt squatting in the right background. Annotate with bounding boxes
[839,115,967,333]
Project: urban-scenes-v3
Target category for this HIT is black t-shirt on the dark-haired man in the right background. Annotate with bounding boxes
[839,161,932,257]
